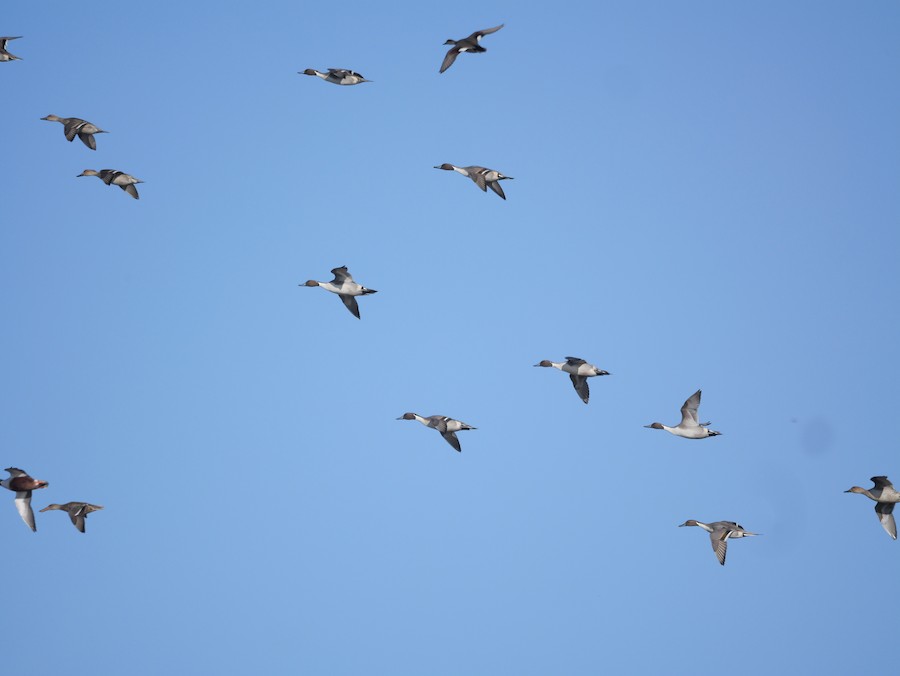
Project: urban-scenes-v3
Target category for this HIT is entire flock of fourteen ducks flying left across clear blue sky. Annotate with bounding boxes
[0,29,900,566]
